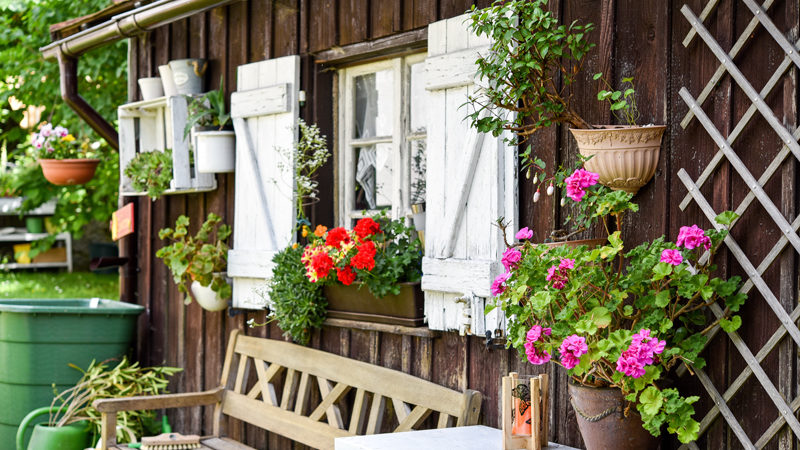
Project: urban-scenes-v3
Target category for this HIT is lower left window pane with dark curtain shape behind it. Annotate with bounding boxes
[355,143,393,209]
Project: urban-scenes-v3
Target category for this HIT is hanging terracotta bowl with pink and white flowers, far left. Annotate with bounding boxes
[32,123,100,186]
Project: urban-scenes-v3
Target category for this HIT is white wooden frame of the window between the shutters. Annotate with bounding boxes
[336,52,427,228]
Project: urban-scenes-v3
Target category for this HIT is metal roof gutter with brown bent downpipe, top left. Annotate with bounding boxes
[39,0,241,150]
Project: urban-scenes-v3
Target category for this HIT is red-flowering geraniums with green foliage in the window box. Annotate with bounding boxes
[301,216,422,298]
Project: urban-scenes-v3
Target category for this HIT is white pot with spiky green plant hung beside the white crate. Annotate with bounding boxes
[183,78,236,173]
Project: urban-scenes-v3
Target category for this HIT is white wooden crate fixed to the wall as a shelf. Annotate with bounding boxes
[117,95,217,195]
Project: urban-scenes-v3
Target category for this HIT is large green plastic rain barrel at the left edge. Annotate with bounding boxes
[0,299,144,449]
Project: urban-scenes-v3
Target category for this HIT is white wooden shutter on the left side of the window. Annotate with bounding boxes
[228,55,300,308]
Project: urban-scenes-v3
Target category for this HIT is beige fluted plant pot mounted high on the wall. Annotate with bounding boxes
[570,125,667,194]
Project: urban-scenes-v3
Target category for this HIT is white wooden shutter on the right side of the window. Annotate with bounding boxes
[422,15,518,335]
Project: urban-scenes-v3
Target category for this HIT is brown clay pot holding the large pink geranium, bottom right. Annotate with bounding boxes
[568,383,660,450]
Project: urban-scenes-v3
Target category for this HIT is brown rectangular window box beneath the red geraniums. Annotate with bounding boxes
[324,283,425,327]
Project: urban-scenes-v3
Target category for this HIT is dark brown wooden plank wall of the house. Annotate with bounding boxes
[122,0,799,449]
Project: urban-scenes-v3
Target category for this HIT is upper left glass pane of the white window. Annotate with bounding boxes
[353,69,394,139]
